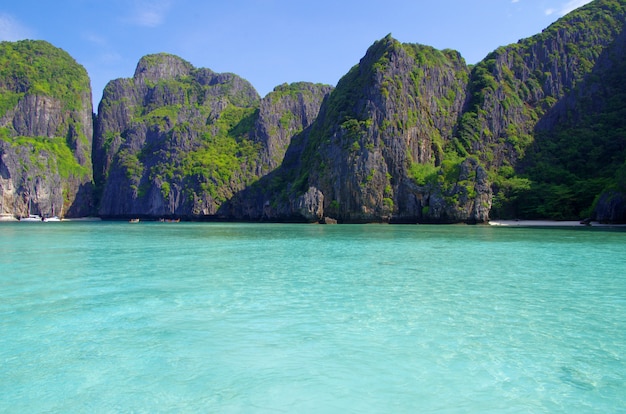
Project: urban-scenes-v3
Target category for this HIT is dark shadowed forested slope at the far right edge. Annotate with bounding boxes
[519,23,626,222]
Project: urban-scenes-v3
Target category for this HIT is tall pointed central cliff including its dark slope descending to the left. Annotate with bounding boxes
[228,36,490,222]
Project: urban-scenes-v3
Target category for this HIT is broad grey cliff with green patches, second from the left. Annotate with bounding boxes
[94,54,328,219]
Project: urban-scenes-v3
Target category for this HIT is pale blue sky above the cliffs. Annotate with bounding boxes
[0,0,590,111]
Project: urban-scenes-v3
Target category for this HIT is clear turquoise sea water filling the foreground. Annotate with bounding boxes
[0,222,626,413]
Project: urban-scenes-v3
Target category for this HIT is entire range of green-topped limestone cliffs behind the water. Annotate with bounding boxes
[0,0,626,223]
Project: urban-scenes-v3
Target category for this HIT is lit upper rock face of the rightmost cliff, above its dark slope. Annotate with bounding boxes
[455,1,625,168]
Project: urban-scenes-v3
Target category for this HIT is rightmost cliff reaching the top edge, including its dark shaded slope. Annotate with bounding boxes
[452,0,626,219]
